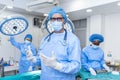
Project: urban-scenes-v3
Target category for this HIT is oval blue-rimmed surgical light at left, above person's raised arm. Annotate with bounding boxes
[0,16,28,36]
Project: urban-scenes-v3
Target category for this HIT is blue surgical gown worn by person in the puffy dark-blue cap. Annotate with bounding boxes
[81,46,105,71]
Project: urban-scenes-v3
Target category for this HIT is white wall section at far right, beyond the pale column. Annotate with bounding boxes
[104,13,120,60]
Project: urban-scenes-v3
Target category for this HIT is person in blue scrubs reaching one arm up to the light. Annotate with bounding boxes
[10,34,36,73]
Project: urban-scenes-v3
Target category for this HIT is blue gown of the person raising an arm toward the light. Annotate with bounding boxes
[10,37,36,73]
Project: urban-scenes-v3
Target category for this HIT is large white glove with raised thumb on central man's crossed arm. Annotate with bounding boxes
[40,52,62,70]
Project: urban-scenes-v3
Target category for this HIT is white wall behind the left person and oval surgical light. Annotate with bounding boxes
[0,11,43,60]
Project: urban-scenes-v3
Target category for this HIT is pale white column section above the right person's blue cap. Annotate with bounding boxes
[86,14,104,45]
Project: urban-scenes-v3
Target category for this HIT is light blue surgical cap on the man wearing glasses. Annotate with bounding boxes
[48,6,67,22]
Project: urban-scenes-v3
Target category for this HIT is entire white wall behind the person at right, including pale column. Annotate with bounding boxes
[87,13,120,61]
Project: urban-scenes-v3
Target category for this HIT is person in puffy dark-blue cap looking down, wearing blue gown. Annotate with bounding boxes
[81,34,110,75]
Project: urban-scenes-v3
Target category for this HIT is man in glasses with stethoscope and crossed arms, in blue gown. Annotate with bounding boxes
[38,6,81,80]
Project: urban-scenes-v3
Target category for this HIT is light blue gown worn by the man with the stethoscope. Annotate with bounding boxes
[39,32,81,80]
